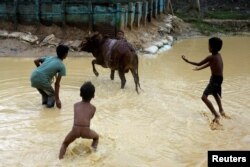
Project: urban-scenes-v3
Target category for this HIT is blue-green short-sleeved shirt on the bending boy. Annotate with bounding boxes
[30,56,66,87]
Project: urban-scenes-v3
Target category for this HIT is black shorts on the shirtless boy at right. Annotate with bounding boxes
[203,75,223,97]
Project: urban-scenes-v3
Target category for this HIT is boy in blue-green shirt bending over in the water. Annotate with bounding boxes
[30,45,69,108]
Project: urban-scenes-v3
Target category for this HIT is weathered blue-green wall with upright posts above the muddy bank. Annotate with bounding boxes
[0,0,168,35]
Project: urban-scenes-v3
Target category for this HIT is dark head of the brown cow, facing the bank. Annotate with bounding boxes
[81,32,103,52]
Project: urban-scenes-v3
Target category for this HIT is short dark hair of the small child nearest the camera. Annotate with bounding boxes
[80,81,95,101]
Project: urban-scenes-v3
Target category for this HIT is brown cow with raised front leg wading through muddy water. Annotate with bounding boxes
[81,32,140,93]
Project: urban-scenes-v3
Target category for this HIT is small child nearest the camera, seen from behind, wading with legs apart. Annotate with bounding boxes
[59,82,99,159]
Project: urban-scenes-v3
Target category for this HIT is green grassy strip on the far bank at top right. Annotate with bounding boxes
[176,9,250,35]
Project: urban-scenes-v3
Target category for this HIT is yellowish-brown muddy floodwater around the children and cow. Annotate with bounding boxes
[0,37,250,167]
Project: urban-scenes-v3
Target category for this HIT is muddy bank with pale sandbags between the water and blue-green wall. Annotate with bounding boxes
[0,15,250,57]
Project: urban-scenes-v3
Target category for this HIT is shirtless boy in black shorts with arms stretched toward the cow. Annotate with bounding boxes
[182,37,230,124]
